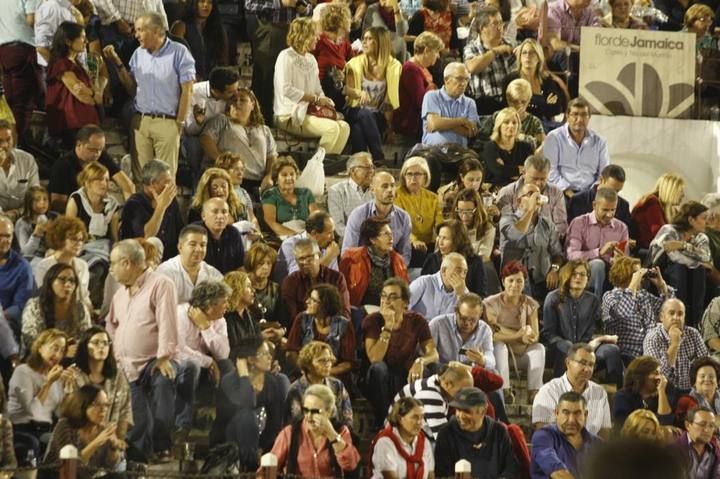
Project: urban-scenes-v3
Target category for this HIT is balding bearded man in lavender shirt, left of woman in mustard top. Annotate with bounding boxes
[342,171,412,264]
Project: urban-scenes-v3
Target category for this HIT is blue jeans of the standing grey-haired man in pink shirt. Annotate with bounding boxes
[127,359,178,459]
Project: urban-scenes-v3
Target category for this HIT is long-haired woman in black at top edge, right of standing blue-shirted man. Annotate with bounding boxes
[171,0,230,81]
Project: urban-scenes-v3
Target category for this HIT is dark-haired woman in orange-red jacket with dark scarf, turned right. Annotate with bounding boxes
[340,216,409,307]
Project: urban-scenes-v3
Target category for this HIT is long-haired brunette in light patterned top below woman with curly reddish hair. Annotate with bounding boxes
[22,263,92,357]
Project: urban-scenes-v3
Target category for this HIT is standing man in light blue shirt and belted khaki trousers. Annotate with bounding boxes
[104,12,195,178]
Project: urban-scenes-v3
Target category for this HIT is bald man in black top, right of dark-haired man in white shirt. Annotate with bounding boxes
[195,198,245,274]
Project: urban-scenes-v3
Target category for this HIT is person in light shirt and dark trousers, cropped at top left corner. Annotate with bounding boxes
[0,0,40,138]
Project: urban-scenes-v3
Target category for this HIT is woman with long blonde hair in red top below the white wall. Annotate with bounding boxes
[630,173,685,249]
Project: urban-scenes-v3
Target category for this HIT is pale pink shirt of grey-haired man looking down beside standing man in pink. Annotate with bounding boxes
[175,303,230,368]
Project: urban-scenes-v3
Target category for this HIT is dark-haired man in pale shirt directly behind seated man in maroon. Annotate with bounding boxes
[278,210,340,274]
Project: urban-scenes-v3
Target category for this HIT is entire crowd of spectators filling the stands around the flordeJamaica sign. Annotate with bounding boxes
[0,0,720,479]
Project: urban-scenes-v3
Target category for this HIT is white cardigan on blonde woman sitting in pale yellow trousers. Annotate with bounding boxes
[273,47,324,126]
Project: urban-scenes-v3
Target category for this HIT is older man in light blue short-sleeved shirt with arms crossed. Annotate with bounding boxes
[421,62,479,147]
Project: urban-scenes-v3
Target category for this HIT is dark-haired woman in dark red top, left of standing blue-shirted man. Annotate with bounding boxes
[45,22,102,149]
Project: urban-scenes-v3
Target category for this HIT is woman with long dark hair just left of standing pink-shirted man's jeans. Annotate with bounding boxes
[75,326,133,446]
